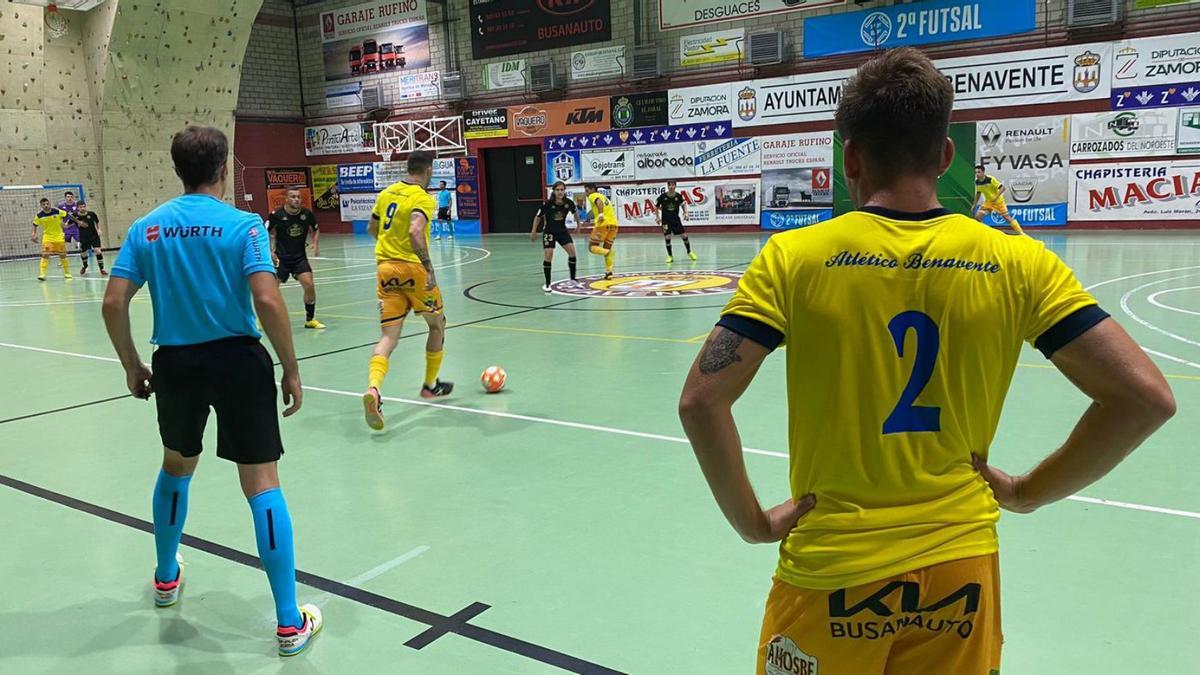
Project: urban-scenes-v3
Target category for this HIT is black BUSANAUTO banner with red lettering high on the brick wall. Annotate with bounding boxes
[470,0,612,59]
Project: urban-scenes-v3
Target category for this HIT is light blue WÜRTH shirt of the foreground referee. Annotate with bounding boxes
[113,195,275,346]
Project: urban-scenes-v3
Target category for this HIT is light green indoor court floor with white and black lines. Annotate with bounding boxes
[0,228,1200,675]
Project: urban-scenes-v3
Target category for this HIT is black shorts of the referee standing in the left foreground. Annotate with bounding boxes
[151,336,283,464]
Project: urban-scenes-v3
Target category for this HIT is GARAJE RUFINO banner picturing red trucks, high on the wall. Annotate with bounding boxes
[320,0,430,80]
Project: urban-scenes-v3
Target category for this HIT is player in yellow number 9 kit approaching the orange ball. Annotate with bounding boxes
[362,151,454,430]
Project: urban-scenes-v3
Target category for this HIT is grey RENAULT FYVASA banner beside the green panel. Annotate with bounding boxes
[976,115,1070,226]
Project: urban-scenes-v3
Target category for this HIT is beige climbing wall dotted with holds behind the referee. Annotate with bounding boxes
[0,0,262,246]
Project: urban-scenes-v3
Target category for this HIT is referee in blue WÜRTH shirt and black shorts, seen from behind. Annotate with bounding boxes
[104,126,322,656]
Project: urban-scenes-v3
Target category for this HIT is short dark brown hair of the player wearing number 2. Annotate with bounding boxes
[834,47,954,185]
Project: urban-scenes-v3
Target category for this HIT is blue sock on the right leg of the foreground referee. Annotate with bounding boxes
[250,488,304,628]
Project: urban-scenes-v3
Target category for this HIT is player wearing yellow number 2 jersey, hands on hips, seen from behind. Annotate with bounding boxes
[679,49,1175,675]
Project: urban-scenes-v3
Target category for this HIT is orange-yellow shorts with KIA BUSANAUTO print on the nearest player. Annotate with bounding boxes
[757,554,1004,675]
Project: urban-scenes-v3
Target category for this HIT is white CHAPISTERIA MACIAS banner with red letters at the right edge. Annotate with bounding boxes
[1070,160,1200,221]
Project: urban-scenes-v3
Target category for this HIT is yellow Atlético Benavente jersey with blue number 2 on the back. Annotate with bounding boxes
[720,208,1108,590]
